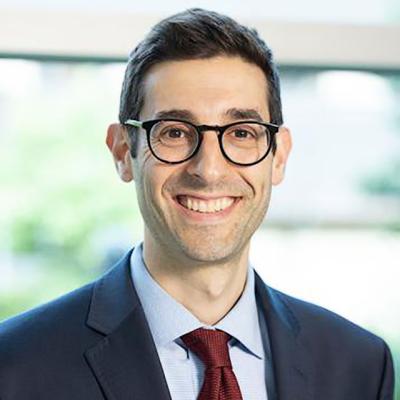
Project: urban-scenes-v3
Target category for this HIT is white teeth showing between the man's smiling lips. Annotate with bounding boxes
[175,195,240,214]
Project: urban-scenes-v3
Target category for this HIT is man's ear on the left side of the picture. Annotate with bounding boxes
[106,123,133,182]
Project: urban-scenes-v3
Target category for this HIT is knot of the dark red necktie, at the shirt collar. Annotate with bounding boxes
[181,328,232,368]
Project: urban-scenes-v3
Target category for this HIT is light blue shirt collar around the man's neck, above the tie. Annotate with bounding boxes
[131,244,264,358]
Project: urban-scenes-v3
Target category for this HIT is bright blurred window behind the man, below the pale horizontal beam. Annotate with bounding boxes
[0,60,400,390]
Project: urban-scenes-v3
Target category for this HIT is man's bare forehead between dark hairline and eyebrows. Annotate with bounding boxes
[141,56,269,120]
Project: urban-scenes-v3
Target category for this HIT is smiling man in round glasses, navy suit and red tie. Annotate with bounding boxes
[0,9,393,400]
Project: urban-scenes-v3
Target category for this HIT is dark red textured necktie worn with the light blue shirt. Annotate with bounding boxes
[181,328,243,400]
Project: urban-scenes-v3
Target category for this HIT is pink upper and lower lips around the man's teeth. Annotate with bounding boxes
[173,193,242,223]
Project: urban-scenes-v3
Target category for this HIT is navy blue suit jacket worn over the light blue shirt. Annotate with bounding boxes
[0,253,394,400]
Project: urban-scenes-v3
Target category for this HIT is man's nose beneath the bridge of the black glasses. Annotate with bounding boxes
[187,130,230,184]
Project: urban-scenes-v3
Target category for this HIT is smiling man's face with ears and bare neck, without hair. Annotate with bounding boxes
[114,55,290,325]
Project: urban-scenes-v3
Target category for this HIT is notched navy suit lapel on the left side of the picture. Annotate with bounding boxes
[85,252,171,400]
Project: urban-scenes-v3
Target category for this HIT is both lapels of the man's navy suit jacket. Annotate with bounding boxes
[85,251,314,400]
